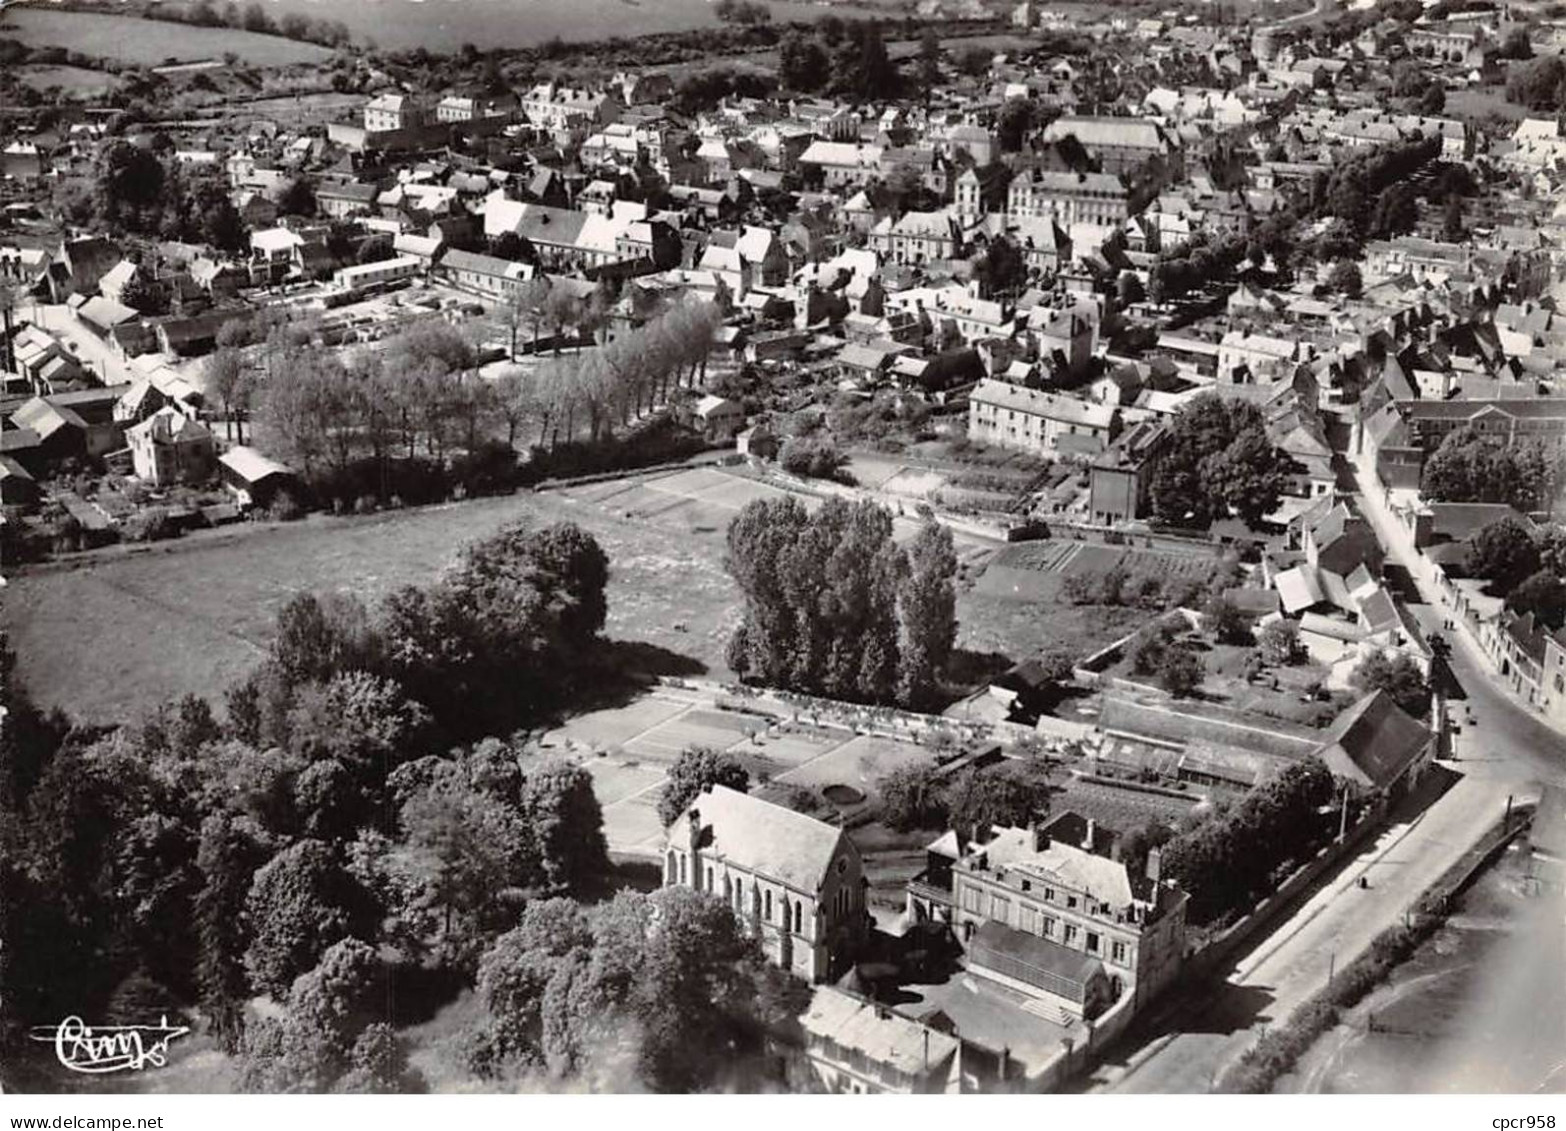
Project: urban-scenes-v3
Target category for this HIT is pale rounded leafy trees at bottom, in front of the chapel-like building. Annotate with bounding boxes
[464,888,810,1092]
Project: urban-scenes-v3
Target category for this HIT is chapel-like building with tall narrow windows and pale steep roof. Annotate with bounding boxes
[664,785,869,982]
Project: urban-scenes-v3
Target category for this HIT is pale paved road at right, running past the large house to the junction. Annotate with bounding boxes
[1087,460,1566,1093]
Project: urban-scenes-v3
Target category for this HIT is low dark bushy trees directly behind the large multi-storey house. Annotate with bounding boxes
[875,761,1049,840]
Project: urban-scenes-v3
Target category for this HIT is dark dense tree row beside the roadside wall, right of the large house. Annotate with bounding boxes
[1149,757,1337,924]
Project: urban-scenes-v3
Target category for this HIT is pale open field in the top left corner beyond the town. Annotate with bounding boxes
[0,8,332,67]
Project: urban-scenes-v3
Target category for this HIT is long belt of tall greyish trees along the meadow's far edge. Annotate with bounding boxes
[236,294,717,508]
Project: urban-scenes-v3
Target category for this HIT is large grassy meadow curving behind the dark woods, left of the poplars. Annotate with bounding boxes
[0,479,738,721]
